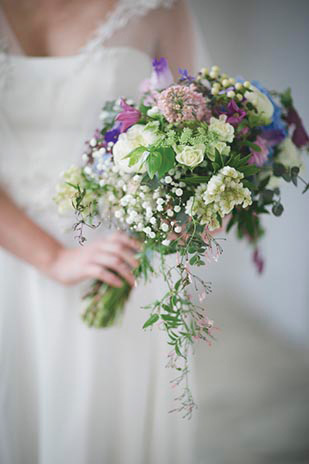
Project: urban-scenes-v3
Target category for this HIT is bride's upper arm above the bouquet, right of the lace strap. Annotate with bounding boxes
[156,0,196,77]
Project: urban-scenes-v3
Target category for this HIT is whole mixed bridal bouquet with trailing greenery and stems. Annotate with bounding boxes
[56,58,309,416]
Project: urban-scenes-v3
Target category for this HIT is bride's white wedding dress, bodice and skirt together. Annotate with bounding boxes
[0,0,202,464]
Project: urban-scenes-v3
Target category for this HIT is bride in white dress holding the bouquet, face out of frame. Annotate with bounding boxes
[0,0,205,464]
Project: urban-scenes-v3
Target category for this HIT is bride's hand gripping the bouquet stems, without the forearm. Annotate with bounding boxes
[47,232,141,287]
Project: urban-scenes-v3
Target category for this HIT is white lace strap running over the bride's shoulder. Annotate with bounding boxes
[82,0,177,53]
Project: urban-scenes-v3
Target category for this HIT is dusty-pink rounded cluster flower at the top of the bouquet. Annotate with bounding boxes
[157,84,210,122]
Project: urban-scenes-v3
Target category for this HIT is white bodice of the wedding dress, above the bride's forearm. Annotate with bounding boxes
[0,0,172,214]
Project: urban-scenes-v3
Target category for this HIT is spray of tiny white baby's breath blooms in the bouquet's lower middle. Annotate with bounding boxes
[99,163,185,246]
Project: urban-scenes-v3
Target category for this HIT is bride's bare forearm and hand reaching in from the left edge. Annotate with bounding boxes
[0,189,139,286]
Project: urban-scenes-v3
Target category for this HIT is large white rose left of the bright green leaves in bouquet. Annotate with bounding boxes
[113,124,158,172]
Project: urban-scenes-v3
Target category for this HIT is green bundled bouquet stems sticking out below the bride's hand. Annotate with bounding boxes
[82,280,131,328]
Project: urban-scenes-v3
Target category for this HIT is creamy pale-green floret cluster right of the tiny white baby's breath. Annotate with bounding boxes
[186,166,252,230]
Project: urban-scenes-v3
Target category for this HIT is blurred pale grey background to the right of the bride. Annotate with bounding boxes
[189,0,309,464]
